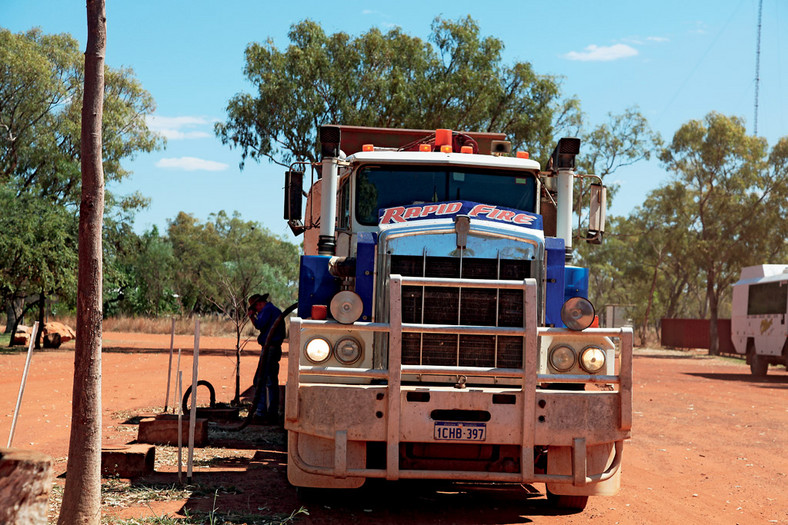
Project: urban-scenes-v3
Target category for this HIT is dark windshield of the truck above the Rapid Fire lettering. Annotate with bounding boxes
[356,166,536,225]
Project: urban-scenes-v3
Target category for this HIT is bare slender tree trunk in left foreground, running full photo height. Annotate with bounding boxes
[58,0,107,525]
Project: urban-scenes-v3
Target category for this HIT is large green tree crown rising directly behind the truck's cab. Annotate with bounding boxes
[215,17,580,167]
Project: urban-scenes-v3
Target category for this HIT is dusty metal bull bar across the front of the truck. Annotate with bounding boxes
[285,275,632,486]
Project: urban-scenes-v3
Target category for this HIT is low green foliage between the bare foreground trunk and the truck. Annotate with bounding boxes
[99,211,298,322]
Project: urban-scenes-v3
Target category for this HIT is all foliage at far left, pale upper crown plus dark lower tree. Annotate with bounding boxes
[0,29,163,316]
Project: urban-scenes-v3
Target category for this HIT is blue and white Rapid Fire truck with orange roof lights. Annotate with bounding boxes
[284,125,632,509]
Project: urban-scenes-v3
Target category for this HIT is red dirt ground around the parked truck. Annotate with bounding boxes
[0,333,788,525]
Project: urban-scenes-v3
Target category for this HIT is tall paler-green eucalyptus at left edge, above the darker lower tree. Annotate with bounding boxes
[0,29,163,328]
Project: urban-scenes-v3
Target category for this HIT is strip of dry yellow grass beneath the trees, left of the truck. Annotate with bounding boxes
[50,316,257,337]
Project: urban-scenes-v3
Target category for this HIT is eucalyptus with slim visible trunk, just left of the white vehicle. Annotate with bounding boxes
[660,113,788,354]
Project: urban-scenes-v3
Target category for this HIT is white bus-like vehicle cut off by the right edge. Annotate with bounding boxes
[731,264,788,377]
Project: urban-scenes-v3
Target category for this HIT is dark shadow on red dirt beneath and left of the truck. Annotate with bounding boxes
[132,427,592,524]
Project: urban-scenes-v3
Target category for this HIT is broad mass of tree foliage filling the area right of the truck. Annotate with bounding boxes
[605,113,788,352]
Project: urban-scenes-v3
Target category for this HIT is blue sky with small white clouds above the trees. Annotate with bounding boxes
[0,0,788,241]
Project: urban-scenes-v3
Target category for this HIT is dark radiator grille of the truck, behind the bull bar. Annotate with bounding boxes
[391,255,531,368]
